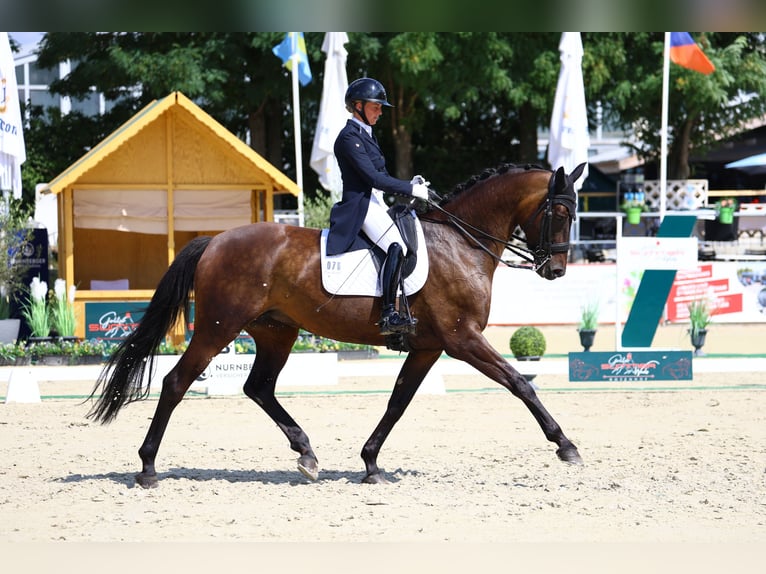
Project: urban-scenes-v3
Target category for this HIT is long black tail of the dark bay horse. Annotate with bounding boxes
[87,236,212,424]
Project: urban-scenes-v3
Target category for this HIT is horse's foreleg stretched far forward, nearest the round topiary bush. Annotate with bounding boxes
[447,334,582,464]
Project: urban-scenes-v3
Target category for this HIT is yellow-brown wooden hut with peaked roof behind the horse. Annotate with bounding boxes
[43,92,299,336]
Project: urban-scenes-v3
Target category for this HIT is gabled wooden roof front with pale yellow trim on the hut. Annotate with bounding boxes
[44,92,299,196]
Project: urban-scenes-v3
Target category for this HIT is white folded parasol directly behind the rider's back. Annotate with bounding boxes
[310,32,350,201]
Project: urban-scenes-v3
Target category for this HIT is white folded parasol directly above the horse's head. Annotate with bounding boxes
[548,32,590,190]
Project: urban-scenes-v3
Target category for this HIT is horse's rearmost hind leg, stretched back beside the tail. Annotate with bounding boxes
[136,338,220,488]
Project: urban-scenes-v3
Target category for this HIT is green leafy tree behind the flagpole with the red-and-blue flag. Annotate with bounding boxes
[583,33,766,179]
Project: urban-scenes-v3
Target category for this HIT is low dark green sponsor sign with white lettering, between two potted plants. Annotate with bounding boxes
[569,350,693,382]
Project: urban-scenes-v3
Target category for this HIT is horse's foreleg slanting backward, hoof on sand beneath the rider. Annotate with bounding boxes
[362,351,441,484]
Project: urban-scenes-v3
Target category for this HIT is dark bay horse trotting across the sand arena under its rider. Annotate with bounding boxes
[88,165,583,487]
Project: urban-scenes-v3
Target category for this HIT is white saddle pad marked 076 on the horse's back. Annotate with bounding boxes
[320,221,428,297]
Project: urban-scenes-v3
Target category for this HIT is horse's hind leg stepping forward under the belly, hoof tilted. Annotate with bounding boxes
[244,324,319,480]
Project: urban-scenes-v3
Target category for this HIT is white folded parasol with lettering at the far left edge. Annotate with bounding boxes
[0,32,27,199]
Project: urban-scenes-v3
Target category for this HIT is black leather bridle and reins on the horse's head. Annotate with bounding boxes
[428,172,577,271]
